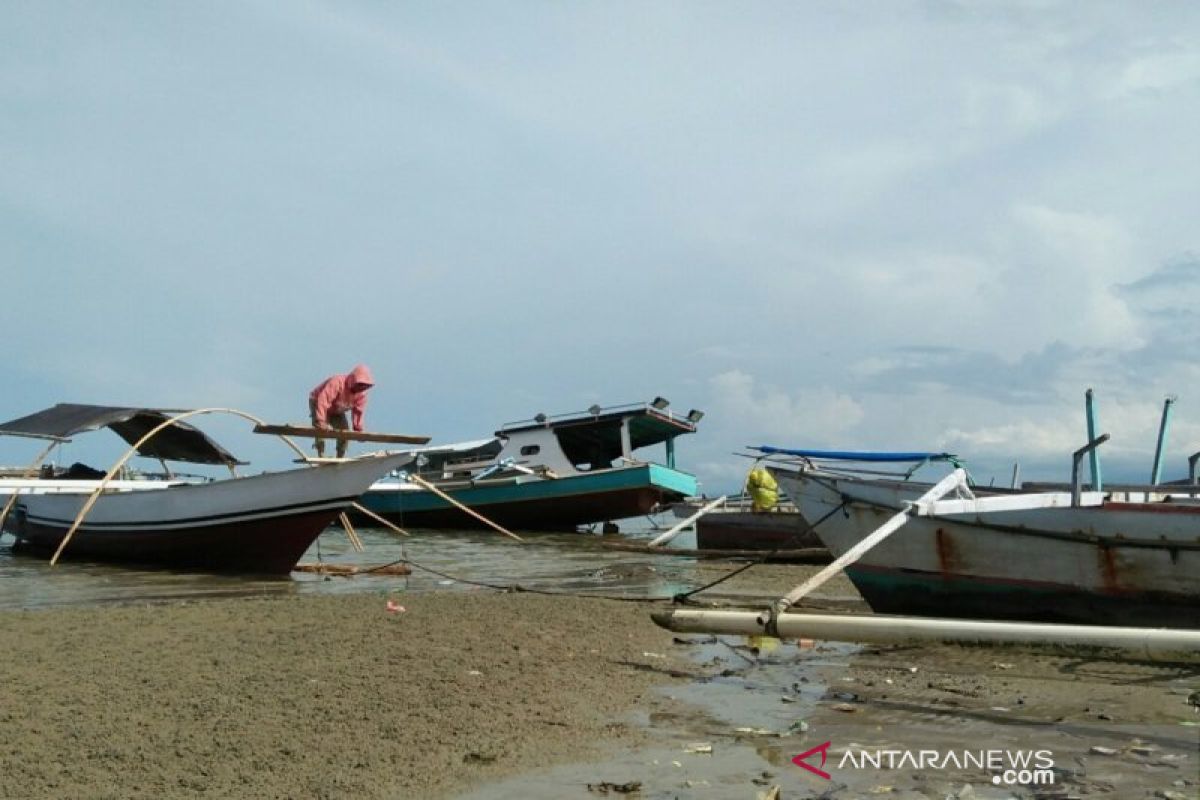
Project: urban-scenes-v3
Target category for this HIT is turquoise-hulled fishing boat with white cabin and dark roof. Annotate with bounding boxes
[361,397,703,531]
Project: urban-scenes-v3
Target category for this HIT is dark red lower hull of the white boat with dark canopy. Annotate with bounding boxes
[7,509,340,575]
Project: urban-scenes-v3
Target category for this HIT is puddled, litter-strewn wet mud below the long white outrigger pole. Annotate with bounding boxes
[457,636,1200,800]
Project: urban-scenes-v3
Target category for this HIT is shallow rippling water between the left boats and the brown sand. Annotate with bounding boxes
[0,528,710,608]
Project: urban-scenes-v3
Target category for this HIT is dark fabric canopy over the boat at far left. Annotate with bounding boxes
[0,403,245,465]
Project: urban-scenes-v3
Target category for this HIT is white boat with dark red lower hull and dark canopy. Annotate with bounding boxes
[0,403,409,575]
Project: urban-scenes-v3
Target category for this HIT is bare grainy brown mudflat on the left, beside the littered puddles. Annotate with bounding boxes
[0,593,691,799]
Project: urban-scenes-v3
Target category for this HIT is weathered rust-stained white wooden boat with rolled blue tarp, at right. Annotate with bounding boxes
[763,447,1200,628]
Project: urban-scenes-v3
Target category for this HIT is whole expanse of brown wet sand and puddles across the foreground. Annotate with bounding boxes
[0,564,1200,800]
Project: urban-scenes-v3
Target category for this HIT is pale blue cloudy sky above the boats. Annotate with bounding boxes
[0,0,1200,494]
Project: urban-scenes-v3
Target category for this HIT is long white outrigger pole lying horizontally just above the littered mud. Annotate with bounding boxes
[650,608,1200,661]
